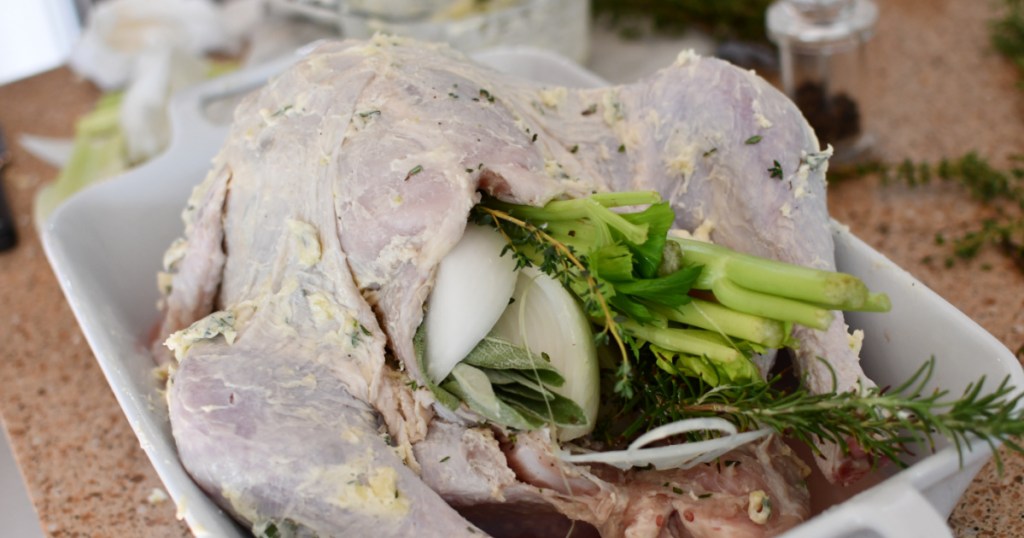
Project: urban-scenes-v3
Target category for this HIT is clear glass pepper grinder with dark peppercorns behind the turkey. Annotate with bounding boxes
[766,0,879,163]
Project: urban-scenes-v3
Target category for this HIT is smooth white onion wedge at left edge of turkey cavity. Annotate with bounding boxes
[423,224,516,383]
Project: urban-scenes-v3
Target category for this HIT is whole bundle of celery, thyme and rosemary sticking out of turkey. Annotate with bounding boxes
[450,193,1024,462]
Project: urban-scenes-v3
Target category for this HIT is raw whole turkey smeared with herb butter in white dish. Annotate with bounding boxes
[156,37,868,537]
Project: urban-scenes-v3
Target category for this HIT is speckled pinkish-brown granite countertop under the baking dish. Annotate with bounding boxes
[0,0,1024,537]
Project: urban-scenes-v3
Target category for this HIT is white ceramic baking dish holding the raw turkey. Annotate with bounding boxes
[43,43,1024,538]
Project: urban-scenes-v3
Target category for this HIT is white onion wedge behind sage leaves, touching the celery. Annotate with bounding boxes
[490,267,600,441]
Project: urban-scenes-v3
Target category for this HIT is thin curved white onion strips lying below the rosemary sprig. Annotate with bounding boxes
[559,417,772,470]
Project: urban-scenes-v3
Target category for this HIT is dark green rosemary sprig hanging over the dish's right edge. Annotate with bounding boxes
[624,359,1024,468]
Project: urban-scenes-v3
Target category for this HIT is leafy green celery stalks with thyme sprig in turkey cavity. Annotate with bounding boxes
[472,192,888,399]
